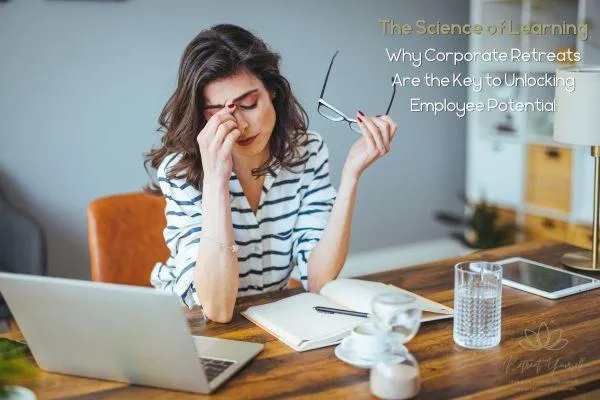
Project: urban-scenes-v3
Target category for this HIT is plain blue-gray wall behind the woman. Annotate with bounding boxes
[0,0,468,278]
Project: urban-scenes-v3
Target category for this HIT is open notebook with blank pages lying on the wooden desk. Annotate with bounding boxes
[242,278,454,351]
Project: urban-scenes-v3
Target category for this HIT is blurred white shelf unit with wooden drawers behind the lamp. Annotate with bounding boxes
[466,0,600,247]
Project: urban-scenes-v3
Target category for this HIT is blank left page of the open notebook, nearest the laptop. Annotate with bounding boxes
[244,293,365,349]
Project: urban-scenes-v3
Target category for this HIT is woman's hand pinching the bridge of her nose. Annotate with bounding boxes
[196,104,242,181]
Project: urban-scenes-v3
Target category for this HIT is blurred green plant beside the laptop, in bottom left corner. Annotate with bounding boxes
[0,339,37,400]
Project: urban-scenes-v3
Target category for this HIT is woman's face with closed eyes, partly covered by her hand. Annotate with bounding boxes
[204,72,275,163]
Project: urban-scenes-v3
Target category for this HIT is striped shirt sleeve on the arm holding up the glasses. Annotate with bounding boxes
[292,137,336,290]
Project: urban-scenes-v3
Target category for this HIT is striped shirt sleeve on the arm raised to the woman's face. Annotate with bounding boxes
[150,155,202,309]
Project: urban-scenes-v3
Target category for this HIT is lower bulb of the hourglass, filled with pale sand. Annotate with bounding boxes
[369,350,421,400]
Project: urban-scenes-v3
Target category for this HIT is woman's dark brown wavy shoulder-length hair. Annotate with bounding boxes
[144,24,308,195]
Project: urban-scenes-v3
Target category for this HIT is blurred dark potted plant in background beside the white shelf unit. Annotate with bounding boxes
[434,196,518,250]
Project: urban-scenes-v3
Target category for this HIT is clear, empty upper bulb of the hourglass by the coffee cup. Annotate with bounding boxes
[372,293,422,343]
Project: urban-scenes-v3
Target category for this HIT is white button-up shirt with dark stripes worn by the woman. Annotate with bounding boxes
[150,132,336,308]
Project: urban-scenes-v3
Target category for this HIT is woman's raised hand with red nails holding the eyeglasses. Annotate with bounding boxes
[344,112,398,178]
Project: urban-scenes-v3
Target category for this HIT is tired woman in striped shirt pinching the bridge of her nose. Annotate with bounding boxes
[146,25,396,322]
